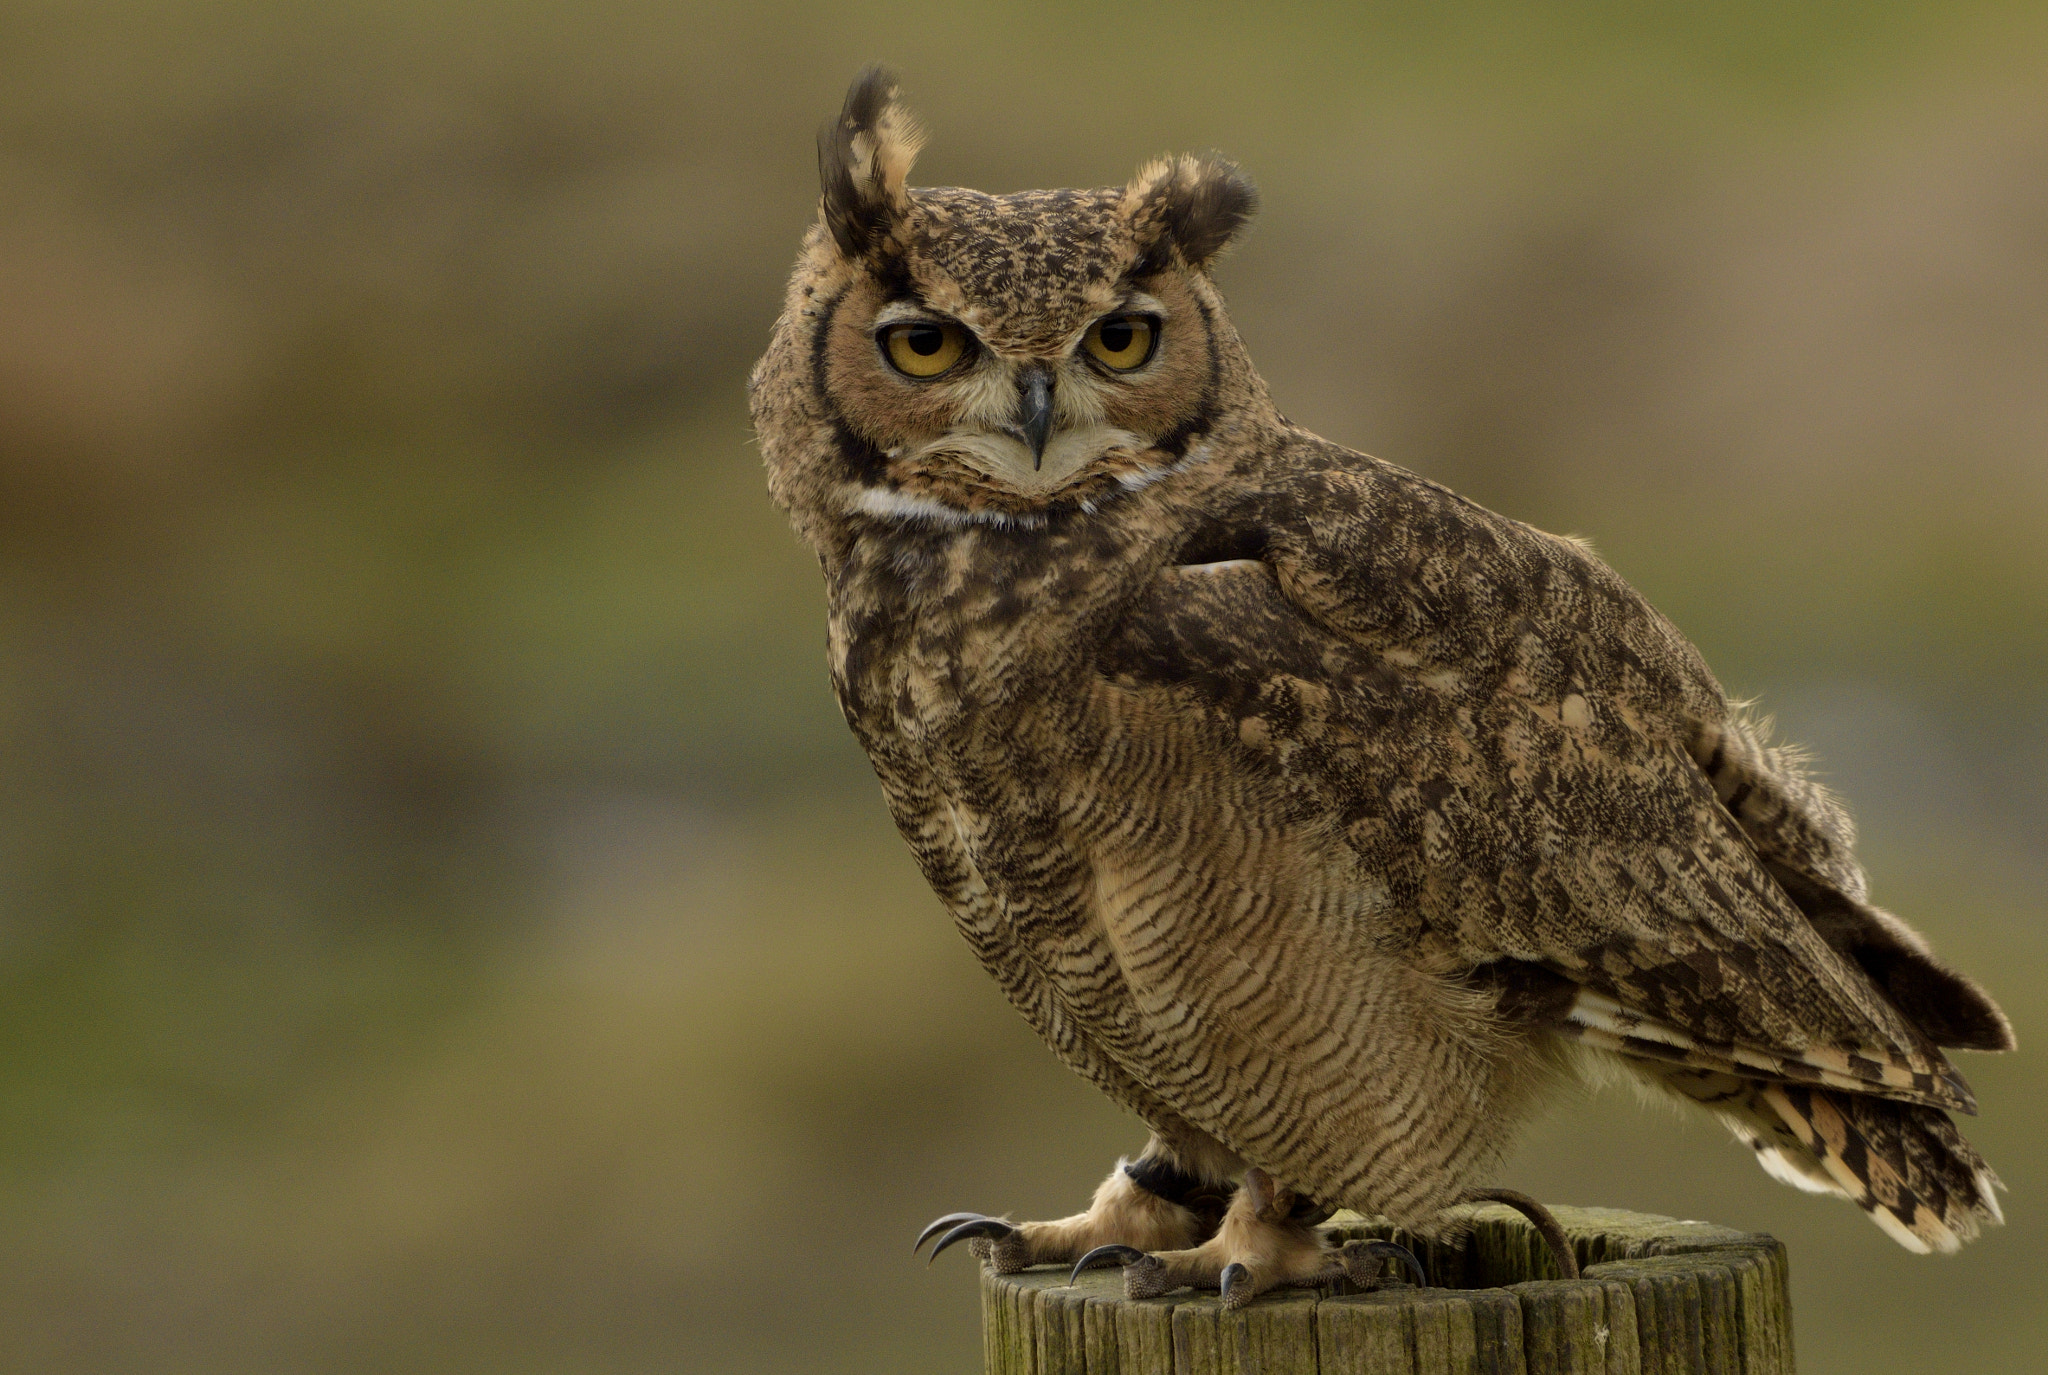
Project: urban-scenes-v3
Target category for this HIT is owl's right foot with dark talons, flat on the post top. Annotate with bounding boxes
[1073,1168,1427,1309]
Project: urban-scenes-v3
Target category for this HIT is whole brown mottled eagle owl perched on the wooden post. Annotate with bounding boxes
[750,70,2013,1303]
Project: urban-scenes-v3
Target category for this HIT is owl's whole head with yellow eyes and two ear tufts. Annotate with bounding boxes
[752,68,1264,543]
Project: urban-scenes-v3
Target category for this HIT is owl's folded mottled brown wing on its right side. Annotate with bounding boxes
[1106,455,1995,1111]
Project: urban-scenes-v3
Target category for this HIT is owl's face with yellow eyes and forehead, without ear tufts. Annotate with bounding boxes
[825,189,1212,500]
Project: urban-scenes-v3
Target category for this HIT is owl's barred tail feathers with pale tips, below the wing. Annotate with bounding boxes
[1657,1070,2005,1254]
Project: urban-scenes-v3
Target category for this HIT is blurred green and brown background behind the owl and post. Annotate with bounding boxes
[0,0,2048,1375]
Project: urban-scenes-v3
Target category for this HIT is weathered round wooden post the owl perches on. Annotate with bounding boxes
[981,1205,1792,1375]
